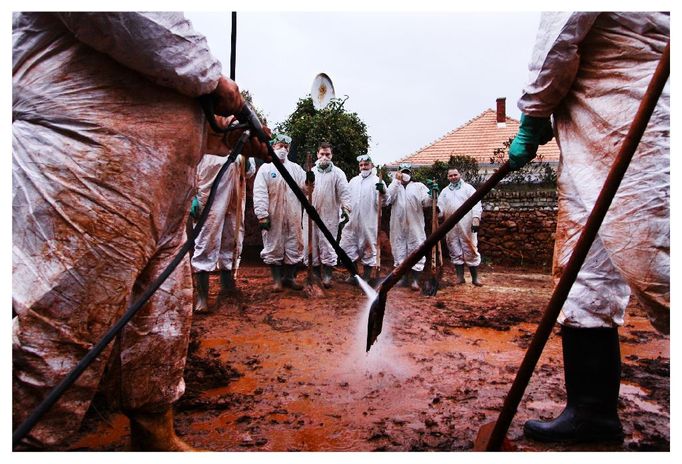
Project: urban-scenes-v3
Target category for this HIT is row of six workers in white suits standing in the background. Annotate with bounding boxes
[192,134,482,304]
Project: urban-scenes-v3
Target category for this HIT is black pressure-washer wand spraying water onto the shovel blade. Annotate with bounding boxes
[199,99,360,279]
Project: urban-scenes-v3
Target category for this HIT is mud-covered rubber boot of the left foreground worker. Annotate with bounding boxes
[126,407,196,451]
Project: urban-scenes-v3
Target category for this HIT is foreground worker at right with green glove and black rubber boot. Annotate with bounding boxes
[509,12,670,442]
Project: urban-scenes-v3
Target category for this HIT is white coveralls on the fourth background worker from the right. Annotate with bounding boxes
[303,162,352,266]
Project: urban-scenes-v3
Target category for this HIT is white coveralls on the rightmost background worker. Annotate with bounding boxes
[438,179,483,267]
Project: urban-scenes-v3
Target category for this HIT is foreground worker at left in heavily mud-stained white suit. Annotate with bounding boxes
[12,12,267,450]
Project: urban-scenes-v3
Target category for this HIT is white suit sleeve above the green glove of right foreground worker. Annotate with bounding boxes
[518,12,599,117]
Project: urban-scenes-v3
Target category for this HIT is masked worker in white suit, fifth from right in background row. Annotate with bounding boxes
[253,134,307,292]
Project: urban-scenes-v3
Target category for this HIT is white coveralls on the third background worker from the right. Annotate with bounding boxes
[332,168,386,267]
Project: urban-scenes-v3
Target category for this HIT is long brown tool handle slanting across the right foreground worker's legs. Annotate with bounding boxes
[476,42,670,451]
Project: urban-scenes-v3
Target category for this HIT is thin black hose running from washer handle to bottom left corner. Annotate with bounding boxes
[12,130,250,448]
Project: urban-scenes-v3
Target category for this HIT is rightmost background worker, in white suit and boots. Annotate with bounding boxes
[438,169,483,287]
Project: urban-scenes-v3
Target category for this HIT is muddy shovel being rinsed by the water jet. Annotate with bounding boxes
[366,161,511,351]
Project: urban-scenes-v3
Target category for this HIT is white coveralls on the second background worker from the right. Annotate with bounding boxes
[386,180,431,272]
